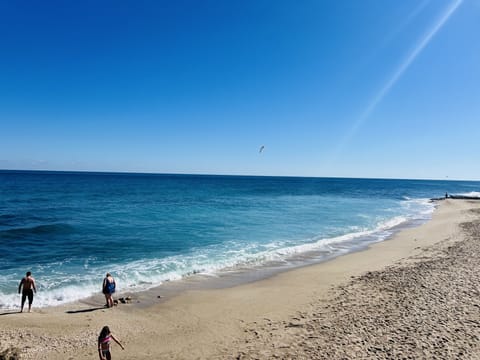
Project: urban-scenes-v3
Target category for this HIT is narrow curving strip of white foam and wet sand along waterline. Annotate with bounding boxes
[0,198,436,313]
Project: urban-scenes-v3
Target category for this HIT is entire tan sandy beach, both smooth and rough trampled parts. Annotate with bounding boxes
[0,199,480,360]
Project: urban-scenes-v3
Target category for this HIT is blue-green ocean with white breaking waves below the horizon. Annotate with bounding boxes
[0,171,480,309]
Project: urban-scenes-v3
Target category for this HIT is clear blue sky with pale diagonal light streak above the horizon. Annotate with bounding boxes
[0,0,480,180]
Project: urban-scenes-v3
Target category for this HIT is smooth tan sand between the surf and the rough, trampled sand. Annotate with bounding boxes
[0,199,480,360]
